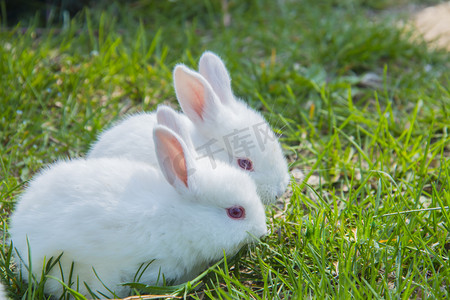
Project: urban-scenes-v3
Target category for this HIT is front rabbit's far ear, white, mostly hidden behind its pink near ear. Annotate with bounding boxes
[156,105,194,149]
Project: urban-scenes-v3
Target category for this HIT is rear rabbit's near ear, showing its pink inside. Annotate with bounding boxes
[173,65,222,124]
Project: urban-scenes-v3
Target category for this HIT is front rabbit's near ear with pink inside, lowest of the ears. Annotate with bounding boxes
[153,125,195,192]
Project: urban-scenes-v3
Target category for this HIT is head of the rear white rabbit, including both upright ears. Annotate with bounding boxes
[174,52,289,204]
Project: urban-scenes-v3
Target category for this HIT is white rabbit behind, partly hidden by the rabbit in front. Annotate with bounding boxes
[87,52,289,204]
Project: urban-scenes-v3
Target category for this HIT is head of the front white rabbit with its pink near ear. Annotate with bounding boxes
[153,125,267,261]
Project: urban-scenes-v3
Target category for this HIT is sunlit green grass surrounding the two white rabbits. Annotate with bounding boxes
[0,0,450,299]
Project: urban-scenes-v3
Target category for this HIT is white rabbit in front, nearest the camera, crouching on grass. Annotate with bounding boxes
[10,125,267,297]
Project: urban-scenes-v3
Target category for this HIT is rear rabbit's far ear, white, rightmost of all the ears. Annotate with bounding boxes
[198,51,234,104]
